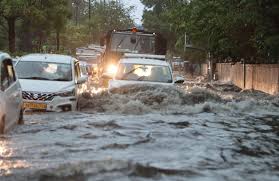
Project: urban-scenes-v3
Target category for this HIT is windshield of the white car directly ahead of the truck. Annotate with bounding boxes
[116,63,172,83]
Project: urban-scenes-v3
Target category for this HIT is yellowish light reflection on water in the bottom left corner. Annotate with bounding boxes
[0,138,29,176]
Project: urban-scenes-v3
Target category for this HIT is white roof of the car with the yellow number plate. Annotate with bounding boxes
[20,54,74,64]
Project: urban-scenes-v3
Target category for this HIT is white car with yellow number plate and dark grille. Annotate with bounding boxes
[16,54,86,112]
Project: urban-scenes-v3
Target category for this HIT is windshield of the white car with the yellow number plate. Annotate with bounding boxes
[16,61,72,81]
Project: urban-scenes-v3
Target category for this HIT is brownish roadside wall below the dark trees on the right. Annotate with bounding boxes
[216,63,279,95]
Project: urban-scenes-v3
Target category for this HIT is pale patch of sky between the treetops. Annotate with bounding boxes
[121,0,144,24]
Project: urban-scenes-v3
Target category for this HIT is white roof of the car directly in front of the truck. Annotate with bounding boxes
[120,58,169,66]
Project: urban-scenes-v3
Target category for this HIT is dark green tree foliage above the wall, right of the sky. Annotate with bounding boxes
[142,0,279,62]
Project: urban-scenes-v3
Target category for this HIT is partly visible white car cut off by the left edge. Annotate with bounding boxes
[0,52,23,134]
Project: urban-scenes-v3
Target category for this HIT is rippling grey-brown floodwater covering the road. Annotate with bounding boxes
[0,82,279,181]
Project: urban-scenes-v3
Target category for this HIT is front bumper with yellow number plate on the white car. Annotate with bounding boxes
[23,97,77,112]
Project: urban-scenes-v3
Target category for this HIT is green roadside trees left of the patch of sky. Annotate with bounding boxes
[0,0,136,53]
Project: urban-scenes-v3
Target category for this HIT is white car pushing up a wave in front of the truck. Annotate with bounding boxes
[106,57,184,90]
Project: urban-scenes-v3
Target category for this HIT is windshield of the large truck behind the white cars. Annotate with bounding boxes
[111,33,155,54]
